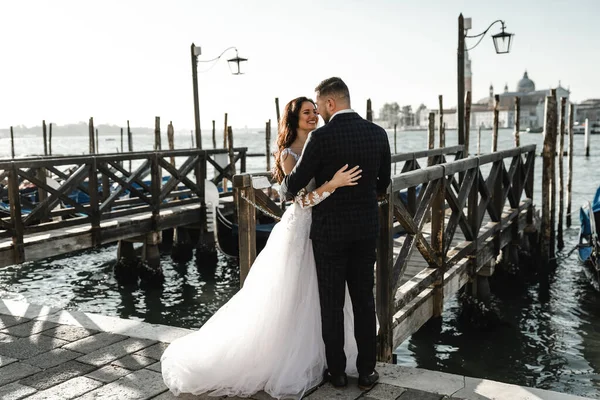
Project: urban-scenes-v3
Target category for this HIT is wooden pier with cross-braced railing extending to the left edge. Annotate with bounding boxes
[0,148,247,267]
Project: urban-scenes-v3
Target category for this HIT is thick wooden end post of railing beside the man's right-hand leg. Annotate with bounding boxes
[375,185,395,363]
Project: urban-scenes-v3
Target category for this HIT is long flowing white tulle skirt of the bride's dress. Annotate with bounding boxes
[161,204,357,399]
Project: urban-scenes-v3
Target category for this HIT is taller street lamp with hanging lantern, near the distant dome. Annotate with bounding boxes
[456,13,514,153]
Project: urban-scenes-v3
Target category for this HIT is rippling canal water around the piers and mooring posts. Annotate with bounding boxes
[0,127,600,398]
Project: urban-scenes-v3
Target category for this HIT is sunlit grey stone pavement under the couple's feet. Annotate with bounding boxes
[0,300,583,400]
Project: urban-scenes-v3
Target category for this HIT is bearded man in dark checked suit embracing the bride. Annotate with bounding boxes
[282,78,391,390]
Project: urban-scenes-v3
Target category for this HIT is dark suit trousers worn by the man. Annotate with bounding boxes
[313,238,377,375]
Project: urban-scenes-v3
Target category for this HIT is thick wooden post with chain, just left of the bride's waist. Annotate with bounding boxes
[233,173,256,287]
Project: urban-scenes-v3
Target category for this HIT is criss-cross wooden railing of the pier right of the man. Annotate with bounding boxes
[376,145,535,361]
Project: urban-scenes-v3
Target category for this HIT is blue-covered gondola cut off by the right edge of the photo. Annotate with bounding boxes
[577,187,600,291]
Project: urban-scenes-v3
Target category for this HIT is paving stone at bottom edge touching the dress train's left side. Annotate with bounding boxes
[78,369,167,400]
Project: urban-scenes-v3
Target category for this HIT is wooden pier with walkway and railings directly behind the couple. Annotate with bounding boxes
[234,145,536,362]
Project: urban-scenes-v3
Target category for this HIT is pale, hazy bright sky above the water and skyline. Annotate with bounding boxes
[0,0,600,131]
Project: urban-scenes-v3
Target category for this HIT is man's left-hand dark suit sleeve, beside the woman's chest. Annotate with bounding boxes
[280,132,322,200]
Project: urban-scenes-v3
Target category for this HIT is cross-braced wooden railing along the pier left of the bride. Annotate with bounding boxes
[0,148,247,263]
